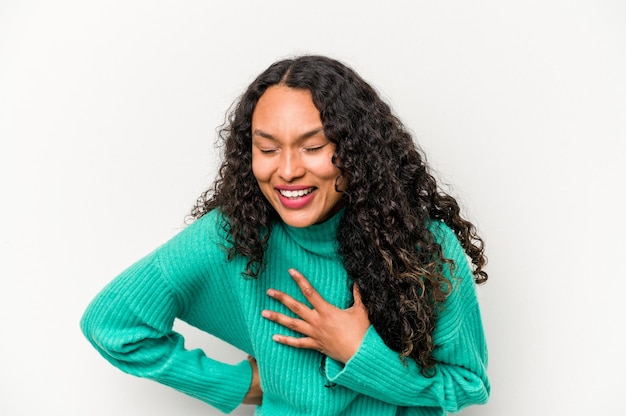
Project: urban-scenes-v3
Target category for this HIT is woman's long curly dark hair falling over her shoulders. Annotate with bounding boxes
[191,56,487,375]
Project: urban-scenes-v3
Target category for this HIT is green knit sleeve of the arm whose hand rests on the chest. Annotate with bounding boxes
[326,225,490,412]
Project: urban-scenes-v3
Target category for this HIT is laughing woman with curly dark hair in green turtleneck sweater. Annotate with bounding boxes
[82,56,489,416]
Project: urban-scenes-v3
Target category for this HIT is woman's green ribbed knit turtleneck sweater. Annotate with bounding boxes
[81,210,489,416]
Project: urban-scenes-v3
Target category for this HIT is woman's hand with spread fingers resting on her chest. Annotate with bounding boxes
[262,269,370,364]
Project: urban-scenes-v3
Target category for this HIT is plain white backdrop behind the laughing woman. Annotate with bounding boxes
[0,0,626,416]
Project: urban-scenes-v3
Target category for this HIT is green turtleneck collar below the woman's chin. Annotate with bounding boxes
[276,208,345,257]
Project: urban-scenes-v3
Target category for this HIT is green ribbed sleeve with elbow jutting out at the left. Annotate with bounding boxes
[81,213,252,413]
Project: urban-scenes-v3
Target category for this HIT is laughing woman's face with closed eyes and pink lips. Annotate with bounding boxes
[252,86,345,227]
